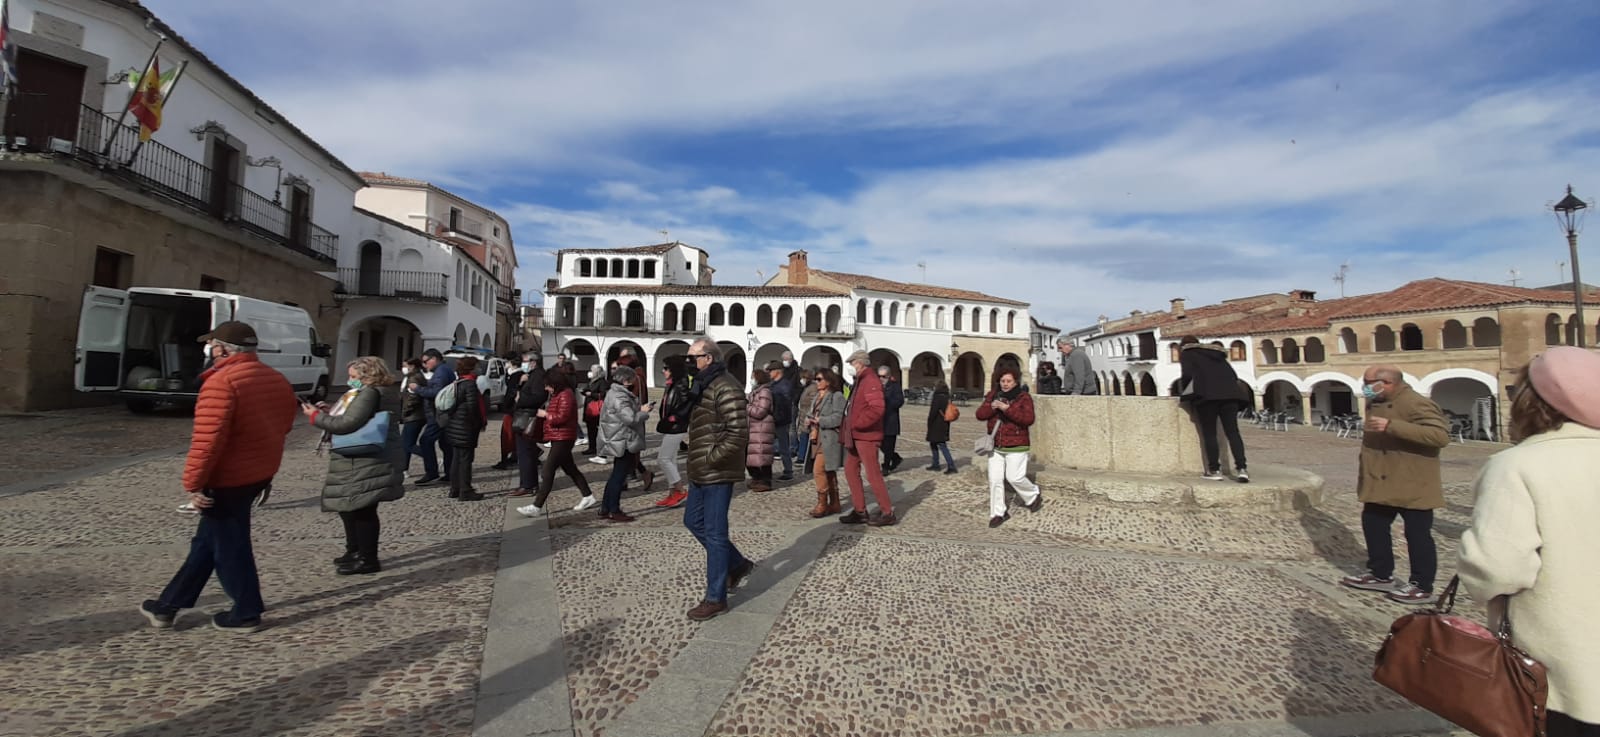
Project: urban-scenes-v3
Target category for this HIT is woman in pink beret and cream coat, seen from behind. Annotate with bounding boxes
[1459,347,1600,737]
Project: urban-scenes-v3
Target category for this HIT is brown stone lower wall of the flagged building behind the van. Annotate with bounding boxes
[0,158,339,411]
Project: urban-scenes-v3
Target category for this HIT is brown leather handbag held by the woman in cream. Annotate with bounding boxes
[1373,576,1549,737]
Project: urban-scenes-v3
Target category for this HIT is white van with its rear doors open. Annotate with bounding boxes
[75,286,333,412]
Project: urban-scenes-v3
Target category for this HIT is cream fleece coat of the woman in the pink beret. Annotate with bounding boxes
[1459,422,1600,724]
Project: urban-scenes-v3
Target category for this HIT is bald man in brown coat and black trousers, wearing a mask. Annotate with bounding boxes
[1339,366,1450,604]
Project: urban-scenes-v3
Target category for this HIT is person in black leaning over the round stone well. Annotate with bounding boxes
[1178,336,1250,484]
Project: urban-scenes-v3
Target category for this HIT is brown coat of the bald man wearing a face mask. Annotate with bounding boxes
[1355,384,1450,510]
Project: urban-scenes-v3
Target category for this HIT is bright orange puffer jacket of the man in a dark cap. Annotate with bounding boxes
[184,353,299,491]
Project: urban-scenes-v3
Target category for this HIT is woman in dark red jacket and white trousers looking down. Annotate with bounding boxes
[978,368,1045,528]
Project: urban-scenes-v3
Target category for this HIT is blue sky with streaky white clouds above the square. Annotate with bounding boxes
[146,0,1600,328]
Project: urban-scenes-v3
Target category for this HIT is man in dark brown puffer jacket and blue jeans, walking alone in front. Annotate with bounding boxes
[683,337,755,622]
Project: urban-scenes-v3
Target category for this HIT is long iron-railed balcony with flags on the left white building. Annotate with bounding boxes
[6,101,339,264]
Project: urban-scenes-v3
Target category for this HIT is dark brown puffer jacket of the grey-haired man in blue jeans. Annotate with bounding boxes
[688,363,750,486]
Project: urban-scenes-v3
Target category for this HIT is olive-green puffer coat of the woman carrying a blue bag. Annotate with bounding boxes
[310,387,403,512]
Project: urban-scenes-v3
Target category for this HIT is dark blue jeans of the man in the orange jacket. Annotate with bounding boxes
[157,480,272,619]
